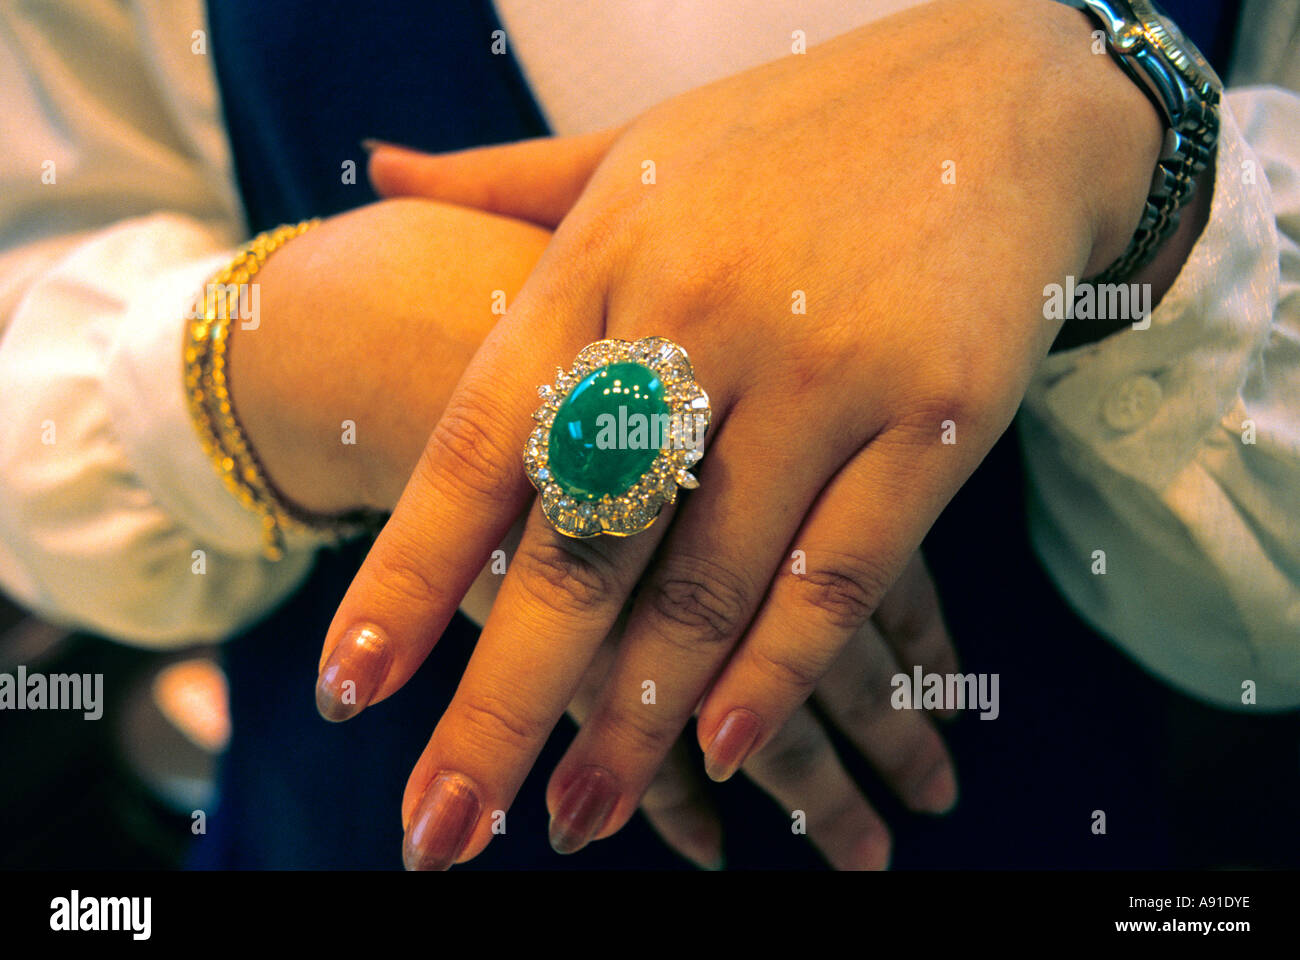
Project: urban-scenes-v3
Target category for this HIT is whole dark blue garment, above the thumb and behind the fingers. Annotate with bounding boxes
[194,0,1296,869]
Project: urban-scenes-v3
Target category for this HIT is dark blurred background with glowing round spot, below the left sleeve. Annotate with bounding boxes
[0,596,230,869]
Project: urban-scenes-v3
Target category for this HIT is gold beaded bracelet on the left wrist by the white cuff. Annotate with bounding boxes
[183,219,382,561]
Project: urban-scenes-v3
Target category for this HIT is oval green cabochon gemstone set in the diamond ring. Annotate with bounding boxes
[547,363,670,500]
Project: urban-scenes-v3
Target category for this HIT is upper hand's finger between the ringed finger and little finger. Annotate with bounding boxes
[547,398,848,848]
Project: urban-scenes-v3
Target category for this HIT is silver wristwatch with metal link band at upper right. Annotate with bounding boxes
[1062,0,1223,282]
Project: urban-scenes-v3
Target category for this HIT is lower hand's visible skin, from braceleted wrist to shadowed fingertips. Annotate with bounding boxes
[229,199,956,868]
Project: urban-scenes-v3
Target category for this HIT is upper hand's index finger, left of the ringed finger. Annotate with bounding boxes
[316,241,603,721]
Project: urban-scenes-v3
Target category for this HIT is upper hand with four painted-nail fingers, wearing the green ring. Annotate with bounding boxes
[322,0,1161,866]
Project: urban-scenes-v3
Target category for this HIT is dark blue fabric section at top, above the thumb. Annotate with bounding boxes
[208,0,549,232]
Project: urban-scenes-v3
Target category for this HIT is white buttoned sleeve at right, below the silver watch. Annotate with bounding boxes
[1021,87,1300,709]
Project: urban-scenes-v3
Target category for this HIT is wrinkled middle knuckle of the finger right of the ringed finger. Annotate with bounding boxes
[646,558,753,647]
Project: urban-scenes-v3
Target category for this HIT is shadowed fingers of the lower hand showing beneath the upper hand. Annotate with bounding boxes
[460,526,957,869]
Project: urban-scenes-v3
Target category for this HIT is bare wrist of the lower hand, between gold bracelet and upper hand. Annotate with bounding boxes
[229,199,550,514]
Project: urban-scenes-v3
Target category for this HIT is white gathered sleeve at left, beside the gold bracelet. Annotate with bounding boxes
[0,0,330,647]
